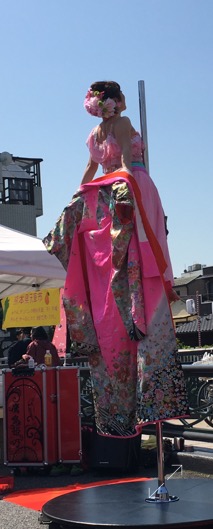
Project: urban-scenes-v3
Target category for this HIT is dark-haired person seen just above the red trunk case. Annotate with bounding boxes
[22,327,61,366]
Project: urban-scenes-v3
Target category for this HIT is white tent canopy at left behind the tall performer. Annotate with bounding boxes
[0,225,66,299]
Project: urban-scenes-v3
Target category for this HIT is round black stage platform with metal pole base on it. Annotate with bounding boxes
[42,478,213,529]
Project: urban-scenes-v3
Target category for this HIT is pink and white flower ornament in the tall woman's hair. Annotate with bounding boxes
[84,88,120,118]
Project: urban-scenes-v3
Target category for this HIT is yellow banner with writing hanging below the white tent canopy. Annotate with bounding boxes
[1,288,60,329]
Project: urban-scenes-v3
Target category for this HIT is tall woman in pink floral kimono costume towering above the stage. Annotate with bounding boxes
[43,81,188,437]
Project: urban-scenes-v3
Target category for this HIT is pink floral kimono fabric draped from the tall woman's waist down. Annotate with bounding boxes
[44,172,188,437]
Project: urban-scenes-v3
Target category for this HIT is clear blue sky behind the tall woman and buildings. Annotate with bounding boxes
[0,0,213,276]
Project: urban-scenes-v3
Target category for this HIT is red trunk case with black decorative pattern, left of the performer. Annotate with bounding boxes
[3,366,82,467]
